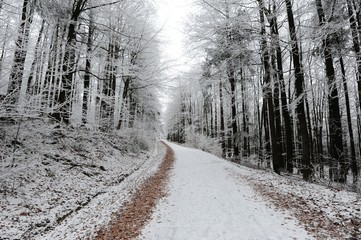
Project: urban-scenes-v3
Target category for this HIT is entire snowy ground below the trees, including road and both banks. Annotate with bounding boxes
[0,120,361,240]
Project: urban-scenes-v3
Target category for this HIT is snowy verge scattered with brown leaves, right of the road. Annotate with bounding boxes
[228,166,361,239]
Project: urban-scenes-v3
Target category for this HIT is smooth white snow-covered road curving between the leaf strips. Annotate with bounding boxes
[140,143,312,240]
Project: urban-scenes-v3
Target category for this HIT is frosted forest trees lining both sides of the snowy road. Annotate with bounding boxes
[0,0,361,187]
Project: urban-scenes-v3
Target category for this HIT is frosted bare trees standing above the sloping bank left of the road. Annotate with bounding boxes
[0,0,161,135]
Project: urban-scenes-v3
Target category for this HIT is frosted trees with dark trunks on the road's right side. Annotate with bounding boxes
[167,0,361,183]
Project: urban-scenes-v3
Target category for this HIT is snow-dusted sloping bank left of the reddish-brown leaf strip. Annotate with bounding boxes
[0,120,165,239]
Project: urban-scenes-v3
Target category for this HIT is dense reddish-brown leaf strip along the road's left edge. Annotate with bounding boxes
[97,144,174,240]
